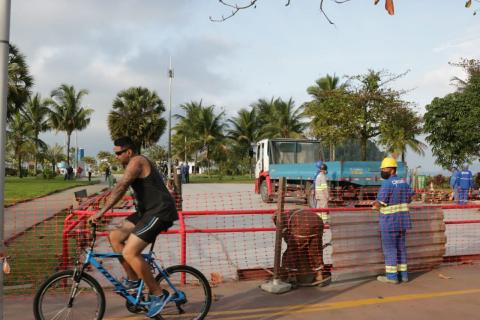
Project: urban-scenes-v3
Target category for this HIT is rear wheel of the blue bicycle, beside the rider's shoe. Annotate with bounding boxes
[156,266,212,320]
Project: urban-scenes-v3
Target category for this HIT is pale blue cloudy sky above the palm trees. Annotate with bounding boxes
[10,0,480,172]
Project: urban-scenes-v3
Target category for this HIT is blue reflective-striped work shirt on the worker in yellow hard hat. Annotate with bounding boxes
[377,175,413,232]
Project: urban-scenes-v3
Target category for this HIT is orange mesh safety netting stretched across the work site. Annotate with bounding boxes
[4,186,480,295]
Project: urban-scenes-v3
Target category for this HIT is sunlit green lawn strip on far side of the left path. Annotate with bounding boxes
[4,177,98,205]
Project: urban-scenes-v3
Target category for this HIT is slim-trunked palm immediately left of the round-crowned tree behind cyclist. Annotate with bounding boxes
[48,84,93,166]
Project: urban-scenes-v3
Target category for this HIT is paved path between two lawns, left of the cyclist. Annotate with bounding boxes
[4,177,108,241]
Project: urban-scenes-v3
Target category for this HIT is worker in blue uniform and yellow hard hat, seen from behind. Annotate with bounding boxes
[373,157,413,283]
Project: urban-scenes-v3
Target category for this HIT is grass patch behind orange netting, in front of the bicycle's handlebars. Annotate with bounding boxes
[4,212,76,294]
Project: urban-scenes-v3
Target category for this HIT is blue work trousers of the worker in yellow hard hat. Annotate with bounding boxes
[382,230,407,280]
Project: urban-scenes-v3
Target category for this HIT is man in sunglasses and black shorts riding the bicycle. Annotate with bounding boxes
[89,137,178,317]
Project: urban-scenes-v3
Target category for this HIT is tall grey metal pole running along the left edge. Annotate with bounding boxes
[0,0,10,319]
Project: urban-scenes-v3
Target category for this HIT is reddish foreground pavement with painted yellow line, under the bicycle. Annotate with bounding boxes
[5,265,480,320]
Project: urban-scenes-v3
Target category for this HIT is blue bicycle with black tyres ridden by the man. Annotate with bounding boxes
[33,225,212,320]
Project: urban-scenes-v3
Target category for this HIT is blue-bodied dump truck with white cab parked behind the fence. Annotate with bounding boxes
[255,139,407,207]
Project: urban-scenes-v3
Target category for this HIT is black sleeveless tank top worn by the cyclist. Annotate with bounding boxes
[131,156,178,221]
